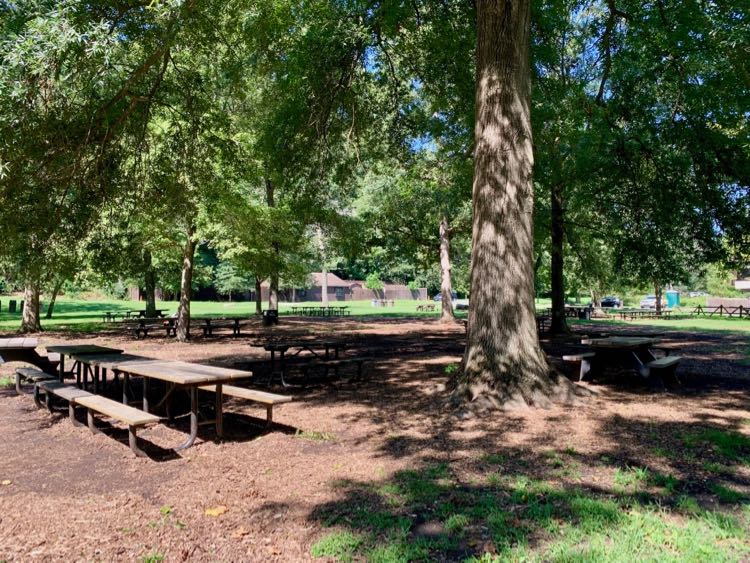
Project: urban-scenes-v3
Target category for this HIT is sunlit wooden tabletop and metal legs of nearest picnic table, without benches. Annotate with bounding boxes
[83,355,253,451]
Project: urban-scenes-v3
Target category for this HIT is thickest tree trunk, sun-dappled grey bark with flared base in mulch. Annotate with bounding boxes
[453,0,573,410]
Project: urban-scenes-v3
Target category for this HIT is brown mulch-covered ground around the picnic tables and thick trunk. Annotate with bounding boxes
[0,319,750,561]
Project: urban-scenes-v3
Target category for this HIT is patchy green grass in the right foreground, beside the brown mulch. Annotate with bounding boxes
[311,458,750,562]
